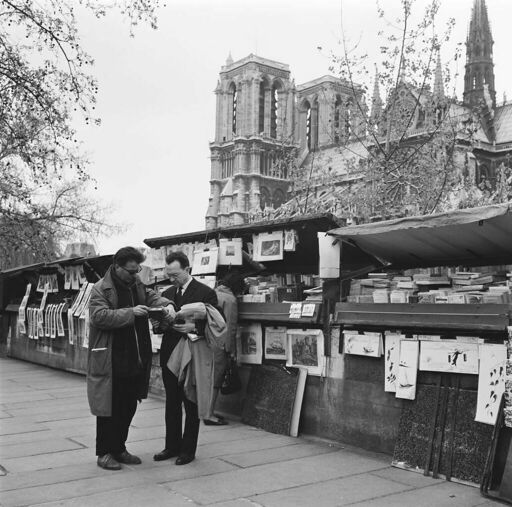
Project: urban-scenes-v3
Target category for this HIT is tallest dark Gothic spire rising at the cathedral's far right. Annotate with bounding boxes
[464,0,496,107]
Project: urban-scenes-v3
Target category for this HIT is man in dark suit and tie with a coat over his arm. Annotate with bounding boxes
[153,252,217,465]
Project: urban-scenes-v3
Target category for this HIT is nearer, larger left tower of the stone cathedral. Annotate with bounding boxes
[206,54,295,229]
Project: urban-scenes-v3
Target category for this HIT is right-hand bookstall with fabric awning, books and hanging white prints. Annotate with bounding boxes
[328,204,512,497]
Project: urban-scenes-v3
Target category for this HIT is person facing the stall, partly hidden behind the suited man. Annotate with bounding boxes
[204,272,245,426]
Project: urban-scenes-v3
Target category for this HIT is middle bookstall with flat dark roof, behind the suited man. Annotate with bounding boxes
[145,214,339,433]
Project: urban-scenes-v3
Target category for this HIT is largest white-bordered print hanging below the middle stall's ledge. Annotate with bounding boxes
[286,329,325,375]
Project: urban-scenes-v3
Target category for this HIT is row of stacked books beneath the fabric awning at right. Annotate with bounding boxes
[347,271,512,304]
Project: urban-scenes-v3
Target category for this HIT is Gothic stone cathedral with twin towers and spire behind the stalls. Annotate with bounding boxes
[206,0,512,229]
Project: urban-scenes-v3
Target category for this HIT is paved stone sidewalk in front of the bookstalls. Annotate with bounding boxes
[0,359,495,507]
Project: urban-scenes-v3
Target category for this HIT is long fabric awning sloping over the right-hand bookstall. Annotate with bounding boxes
[328,203,512,269]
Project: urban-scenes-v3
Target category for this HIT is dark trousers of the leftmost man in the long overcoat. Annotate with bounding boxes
[96,377,140,456]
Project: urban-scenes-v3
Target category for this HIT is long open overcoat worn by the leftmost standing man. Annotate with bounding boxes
[87,268,170,417]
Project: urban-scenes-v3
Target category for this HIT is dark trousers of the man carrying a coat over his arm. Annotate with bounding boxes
[162,366,199,456]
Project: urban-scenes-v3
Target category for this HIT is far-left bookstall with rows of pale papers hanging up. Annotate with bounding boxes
[0,255,112,373]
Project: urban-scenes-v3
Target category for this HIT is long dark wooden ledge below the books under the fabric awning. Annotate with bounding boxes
[336,303,512,332]
